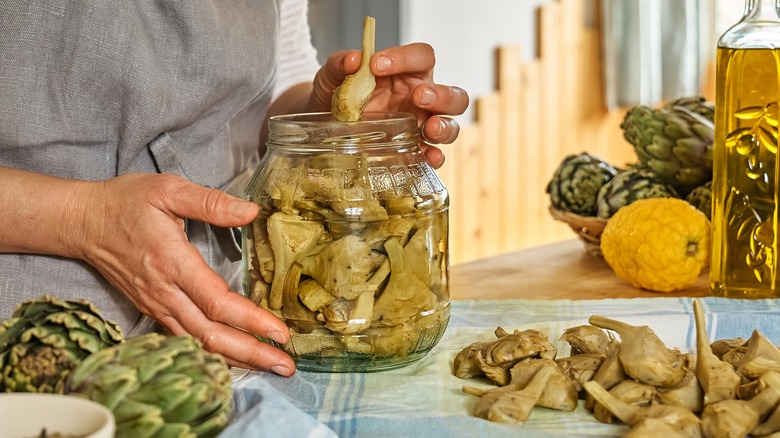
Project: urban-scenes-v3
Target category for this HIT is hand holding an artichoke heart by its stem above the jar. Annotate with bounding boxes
[310,43,469,168]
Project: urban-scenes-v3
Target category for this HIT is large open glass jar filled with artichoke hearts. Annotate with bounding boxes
[242,113,450,372]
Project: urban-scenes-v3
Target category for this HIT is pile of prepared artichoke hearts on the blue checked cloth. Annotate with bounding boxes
[453,300,780,438]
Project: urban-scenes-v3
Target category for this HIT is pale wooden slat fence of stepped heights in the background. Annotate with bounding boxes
[438,0,712,264]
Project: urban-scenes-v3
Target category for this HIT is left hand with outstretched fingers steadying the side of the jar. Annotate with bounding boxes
[73,174,295,376]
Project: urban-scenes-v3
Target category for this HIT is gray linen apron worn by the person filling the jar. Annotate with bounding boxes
[0,0,281,334]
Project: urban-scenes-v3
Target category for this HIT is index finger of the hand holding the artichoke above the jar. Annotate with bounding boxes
[370,43,436,79]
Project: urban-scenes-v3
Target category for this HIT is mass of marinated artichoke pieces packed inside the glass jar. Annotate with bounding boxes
[245,153,449,357]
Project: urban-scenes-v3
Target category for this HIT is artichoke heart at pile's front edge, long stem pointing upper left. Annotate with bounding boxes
[585,381,701,438]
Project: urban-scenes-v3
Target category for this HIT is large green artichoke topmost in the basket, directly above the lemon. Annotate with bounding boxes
[620,98,715,195]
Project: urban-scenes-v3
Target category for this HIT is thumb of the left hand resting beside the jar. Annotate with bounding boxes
[169,182,260,227]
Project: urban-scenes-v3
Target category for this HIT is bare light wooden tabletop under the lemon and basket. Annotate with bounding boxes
[450,239,709,300]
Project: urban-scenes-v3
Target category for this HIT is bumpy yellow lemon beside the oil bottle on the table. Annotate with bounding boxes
[601,198,710,292]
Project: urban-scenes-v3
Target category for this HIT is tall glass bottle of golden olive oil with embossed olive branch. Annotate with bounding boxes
[710,0,780,298]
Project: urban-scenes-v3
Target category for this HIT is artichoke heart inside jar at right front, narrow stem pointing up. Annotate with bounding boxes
[372,237,435,326]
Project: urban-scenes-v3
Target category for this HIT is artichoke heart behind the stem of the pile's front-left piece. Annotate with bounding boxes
[509,359,577,412]
